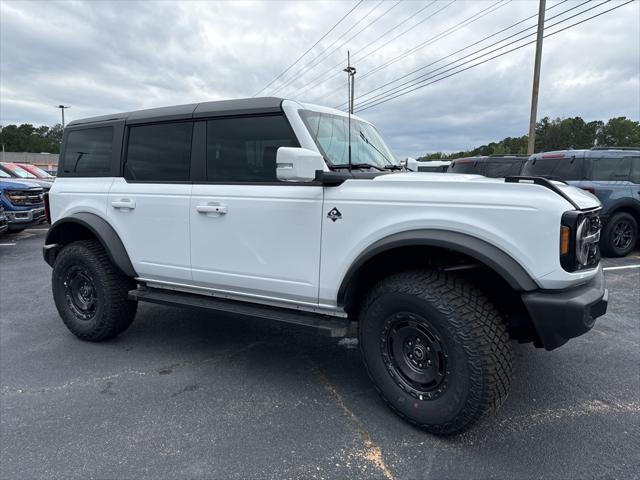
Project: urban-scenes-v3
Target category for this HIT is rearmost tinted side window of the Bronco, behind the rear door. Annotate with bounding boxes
[62,127,113,177]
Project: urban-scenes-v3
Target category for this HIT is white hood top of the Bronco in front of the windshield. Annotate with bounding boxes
[374,172,602,210]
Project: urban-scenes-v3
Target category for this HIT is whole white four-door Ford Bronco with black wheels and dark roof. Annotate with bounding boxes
[44,98,608,435]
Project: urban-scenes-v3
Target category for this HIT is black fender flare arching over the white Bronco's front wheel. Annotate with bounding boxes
[337,229,540,305]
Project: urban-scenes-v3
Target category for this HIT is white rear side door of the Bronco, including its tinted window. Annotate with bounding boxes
[107,121,193,283]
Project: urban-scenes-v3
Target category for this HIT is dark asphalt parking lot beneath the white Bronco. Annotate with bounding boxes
[0,229,640,479]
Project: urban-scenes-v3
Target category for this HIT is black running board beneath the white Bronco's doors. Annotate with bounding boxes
[129,287,351,337]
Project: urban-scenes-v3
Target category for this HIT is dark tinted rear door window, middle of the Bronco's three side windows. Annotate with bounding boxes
[124,122,193,182]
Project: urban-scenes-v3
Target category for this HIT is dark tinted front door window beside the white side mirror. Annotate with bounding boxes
[207,115,298,182]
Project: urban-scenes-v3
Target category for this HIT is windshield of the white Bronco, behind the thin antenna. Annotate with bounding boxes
[300,110,400,169]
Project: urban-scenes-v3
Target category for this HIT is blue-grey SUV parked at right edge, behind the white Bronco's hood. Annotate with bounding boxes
[522,147,640,257]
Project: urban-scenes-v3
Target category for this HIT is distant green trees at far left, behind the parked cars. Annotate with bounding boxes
[0,123,62,153]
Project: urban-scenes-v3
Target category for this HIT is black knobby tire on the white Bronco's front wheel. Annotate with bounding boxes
[359,269,513,435]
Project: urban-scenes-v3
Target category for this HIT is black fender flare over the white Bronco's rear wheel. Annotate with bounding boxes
[43,212,137,277]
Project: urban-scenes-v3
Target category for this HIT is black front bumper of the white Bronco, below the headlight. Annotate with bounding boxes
[522,268,609,350]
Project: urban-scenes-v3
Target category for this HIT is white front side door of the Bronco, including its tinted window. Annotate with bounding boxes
[190,114,323,303]
